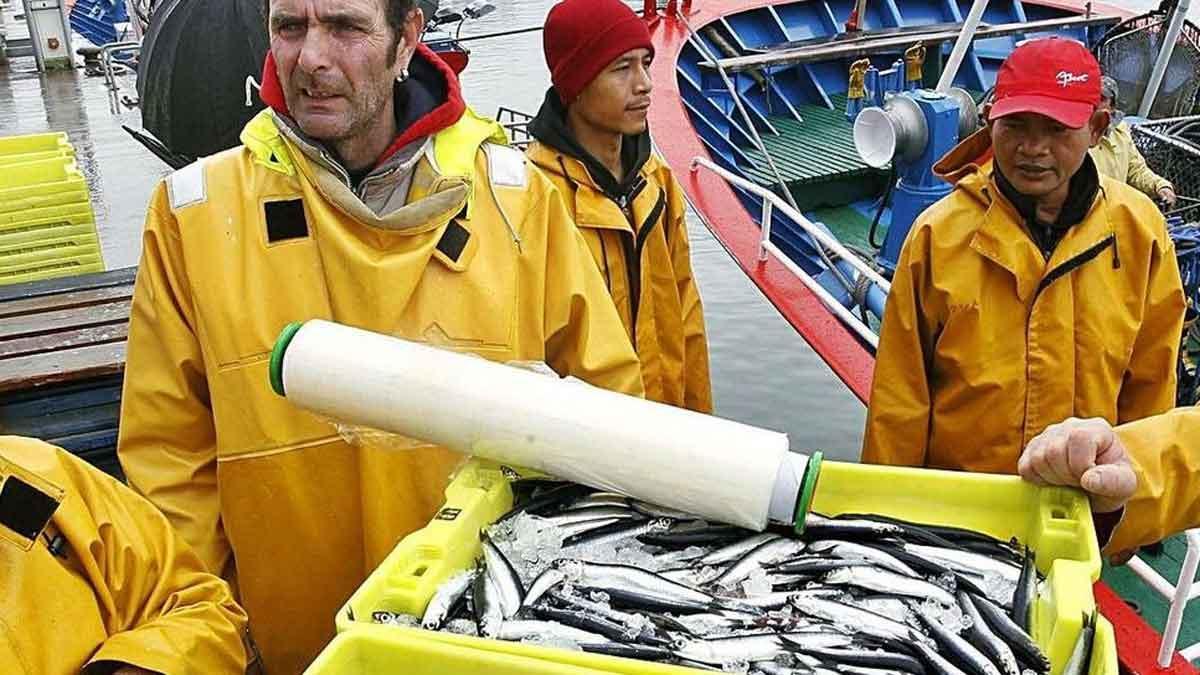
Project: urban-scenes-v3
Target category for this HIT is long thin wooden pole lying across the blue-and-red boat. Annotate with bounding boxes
[700,16,1118,72]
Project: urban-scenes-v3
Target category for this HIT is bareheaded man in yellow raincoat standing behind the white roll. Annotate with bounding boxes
[118,0,643,675]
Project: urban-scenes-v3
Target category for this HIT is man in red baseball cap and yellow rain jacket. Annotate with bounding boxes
[863,38,1184,473]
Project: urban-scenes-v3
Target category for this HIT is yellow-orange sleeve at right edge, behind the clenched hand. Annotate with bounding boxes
[1105,407,1200,552]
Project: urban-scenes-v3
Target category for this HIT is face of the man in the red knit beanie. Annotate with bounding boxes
[571,49,654,135]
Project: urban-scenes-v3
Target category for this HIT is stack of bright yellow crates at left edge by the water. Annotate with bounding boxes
[0,133,104,285]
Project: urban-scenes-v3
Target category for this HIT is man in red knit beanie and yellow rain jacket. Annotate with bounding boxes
[528,0,713,412]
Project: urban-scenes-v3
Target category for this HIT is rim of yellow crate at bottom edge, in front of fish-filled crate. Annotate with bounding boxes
[305,626,667,675]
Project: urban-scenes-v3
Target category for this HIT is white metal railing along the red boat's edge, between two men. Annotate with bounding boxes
[691,156,892,347]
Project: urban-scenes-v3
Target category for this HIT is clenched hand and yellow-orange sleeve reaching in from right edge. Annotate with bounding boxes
[1020,407,1200,552]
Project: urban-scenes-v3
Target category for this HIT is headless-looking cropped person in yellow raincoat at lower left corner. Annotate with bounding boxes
[0,436,247,675]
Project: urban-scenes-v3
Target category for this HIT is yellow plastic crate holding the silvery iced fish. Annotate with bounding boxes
[336,460,1118,675]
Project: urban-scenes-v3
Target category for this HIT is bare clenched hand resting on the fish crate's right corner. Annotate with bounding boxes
[1016,418,1138,513]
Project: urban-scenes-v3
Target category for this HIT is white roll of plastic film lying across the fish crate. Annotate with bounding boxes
[282,321,788,530]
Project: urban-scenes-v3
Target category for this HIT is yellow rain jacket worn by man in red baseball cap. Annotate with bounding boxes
[863,130,1184,473]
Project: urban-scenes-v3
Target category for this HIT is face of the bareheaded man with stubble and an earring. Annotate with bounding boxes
[269,0,416,142]
